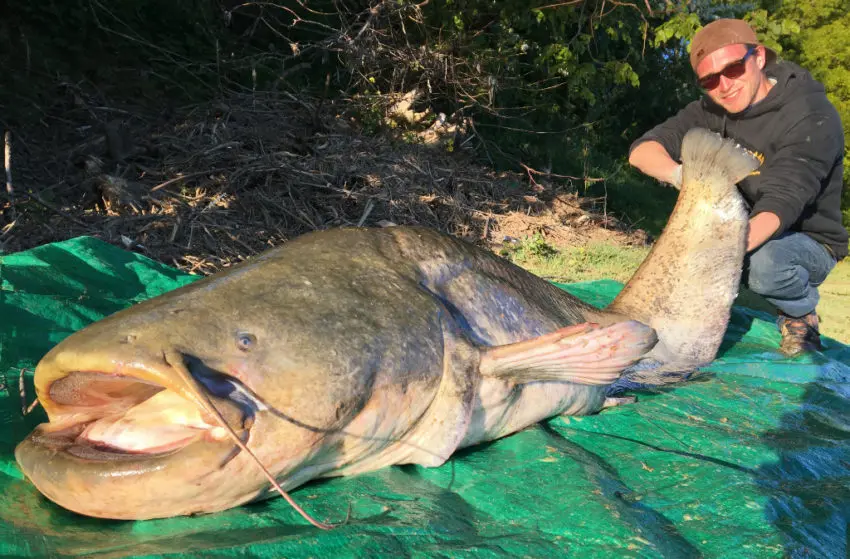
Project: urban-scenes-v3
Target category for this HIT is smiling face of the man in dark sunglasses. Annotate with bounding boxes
[697,45,767,114]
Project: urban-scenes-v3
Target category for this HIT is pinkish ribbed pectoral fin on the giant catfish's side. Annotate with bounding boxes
[479,320,658,385]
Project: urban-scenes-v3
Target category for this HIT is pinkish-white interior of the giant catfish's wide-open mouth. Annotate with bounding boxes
[32,371,243,461]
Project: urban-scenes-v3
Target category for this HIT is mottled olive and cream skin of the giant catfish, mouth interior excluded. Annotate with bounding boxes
[11,127,754,519]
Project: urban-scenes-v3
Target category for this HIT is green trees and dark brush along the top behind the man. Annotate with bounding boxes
[0,0,850,232]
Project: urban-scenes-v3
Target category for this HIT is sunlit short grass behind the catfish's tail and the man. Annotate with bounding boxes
[502,237,850,344]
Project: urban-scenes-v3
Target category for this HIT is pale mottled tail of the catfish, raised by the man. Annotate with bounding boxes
[606,128,760,392]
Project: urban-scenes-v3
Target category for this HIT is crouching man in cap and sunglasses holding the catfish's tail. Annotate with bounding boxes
[629,19,848,356]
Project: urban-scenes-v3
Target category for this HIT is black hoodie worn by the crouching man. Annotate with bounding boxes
[629,62,848,260]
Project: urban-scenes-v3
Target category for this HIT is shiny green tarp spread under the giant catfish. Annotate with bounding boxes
[0,237,850,558]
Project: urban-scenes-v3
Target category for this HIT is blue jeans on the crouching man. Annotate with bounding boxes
[741,233,836,318]
